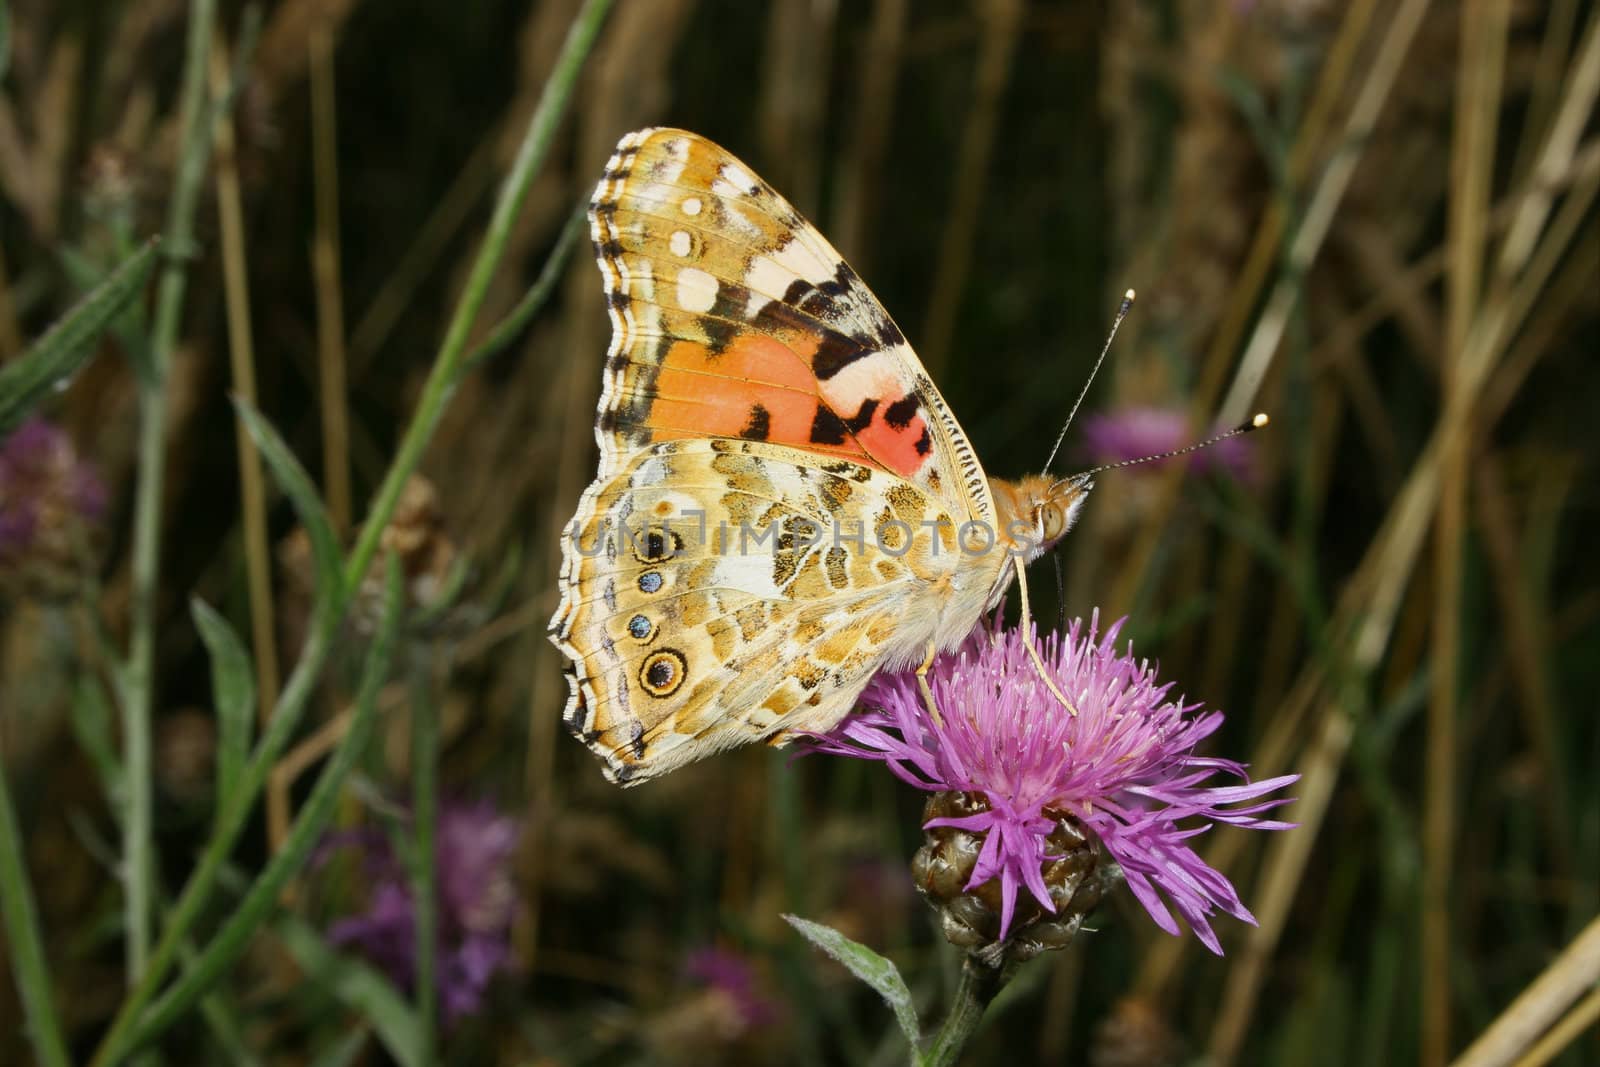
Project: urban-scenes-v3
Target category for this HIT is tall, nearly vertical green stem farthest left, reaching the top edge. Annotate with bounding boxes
[122,0,216,985]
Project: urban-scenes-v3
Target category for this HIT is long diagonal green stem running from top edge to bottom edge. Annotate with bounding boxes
[91,0,611,1067]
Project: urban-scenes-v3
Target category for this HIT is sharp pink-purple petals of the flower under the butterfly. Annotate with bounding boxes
[814,613,1299,953]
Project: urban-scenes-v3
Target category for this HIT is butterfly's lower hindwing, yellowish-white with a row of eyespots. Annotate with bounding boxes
[552,438,970,784]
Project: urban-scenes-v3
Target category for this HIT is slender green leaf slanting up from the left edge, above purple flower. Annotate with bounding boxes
[0,238,157,437]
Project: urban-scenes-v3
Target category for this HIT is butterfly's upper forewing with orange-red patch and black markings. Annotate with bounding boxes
[590,130,994,522]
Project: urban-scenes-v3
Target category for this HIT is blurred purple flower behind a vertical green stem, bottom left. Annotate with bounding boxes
[314,801,518,1022]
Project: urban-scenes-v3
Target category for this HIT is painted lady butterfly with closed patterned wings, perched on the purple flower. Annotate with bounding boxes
[550,130,1091,784]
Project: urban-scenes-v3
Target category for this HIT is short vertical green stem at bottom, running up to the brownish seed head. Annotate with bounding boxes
[411,643,438,1067]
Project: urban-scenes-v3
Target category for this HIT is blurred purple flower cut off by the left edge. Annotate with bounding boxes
[0,416,106,563]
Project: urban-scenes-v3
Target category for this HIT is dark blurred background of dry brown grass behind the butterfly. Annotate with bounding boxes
[0,0,1600,1064]
